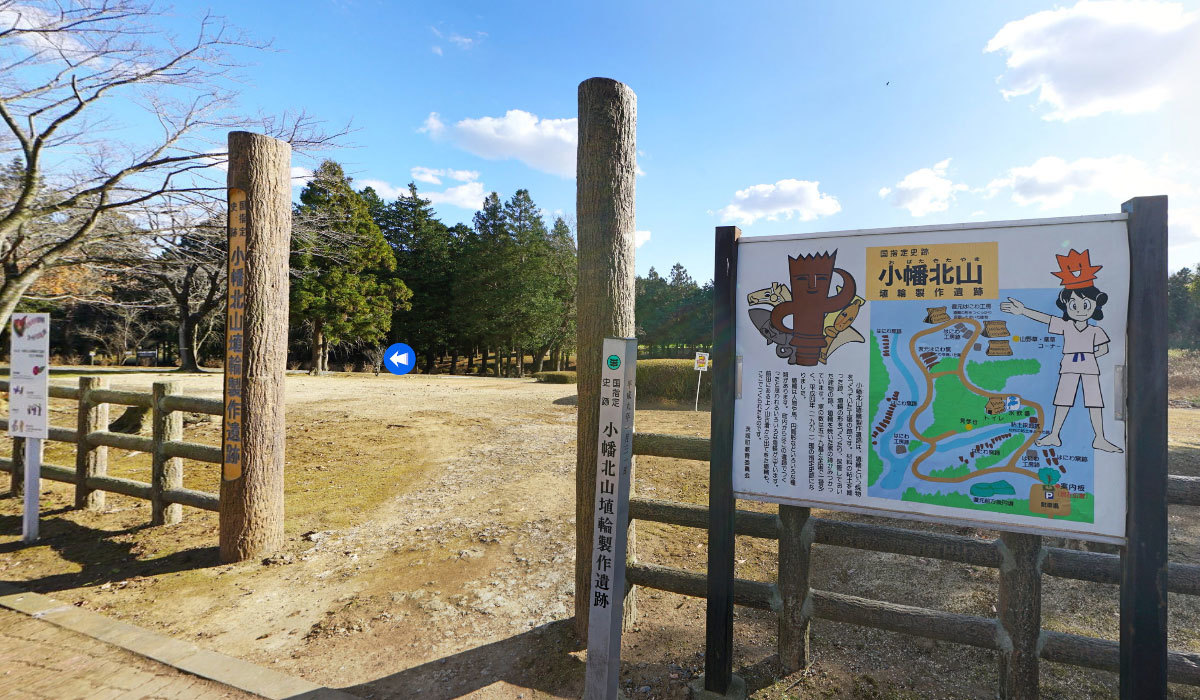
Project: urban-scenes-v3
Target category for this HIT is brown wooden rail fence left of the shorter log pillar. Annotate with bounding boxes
[0,377,223,525]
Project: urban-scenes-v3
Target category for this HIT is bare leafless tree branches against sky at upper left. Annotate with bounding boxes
[0,0,344,325]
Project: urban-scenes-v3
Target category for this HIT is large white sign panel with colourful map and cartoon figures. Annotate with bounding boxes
[733,215,1136,542]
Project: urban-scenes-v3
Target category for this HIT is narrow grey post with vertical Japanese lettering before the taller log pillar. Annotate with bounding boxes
[583,337,637,700]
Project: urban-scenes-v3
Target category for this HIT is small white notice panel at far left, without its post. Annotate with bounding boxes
[8,313,50,438]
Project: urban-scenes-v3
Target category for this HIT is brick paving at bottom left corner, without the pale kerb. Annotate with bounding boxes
[0,608,256,700]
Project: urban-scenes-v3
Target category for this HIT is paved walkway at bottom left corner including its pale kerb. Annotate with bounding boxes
[0,582,354,700]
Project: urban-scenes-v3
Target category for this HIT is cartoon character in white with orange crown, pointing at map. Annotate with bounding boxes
[1000,249,1124,453]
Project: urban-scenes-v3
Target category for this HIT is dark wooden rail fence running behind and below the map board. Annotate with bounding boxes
[625,433,1200,698]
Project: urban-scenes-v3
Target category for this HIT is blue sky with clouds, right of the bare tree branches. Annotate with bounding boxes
[169,0,1200,280]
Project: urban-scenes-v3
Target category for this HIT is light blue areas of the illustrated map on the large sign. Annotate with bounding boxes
[868,289,1111,499]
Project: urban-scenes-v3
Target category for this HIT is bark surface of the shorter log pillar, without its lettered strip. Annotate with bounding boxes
[220,131,292,562]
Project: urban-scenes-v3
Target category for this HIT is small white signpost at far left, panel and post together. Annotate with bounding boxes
[8,313,50,542]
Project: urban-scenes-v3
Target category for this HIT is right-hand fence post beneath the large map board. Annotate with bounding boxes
[998,532,1045,700]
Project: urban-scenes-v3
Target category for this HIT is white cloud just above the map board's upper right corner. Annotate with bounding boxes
[984,155,1195,209]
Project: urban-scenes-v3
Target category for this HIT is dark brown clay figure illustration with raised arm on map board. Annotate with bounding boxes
[770,251,857,367]
